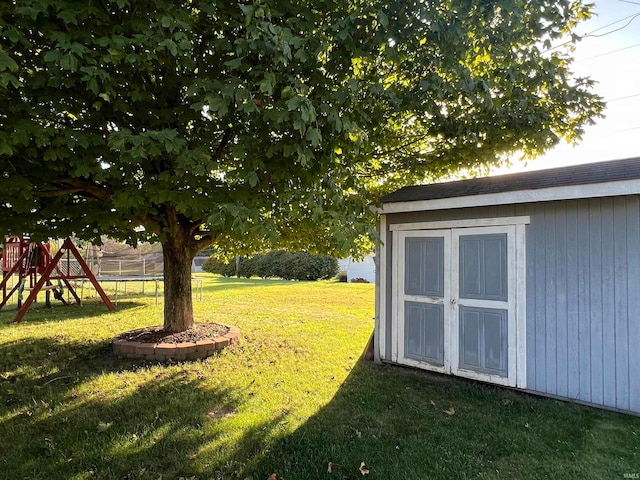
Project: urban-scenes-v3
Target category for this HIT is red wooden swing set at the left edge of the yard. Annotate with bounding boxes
[0,234,115,323]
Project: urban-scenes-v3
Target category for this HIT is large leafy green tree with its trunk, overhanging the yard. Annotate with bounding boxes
[0,0,602,331]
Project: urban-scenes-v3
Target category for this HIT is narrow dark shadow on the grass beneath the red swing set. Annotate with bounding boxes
[0,300,147,326]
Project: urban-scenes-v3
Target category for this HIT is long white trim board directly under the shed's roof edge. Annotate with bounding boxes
[374,179,640,213]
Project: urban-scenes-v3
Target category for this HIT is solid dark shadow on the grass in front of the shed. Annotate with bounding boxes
[247,361,640,480]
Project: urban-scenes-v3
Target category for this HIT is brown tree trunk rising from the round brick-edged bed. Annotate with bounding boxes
[162,228,196,333]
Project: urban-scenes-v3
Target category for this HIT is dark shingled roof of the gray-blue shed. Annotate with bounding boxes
[381,157,640,204]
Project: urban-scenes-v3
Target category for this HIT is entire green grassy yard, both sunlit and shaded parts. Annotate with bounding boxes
[0,276,640,480]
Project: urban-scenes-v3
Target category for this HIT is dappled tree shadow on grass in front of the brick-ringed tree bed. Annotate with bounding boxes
[0,337,284,479]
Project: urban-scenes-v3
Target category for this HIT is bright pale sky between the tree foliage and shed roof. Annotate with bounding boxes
[492,0,640,174]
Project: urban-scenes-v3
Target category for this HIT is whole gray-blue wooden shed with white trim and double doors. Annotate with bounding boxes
[374,158,640,414]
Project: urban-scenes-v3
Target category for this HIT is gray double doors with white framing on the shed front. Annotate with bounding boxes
[395,226,517,385]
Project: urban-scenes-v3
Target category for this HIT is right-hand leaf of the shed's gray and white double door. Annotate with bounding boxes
[452,226,517,386]
